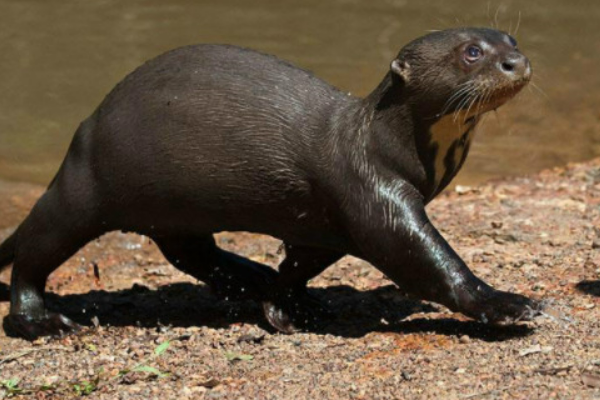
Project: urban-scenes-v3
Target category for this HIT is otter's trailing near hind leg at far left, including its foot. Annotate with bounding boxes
[4,184,103,340]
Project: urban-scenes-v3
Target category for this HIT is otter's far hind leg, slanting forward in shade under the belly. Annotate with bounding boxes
[153,235,277,301]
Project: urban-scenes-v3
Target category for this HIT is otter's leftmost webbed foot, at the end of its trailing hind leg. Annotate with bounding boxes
[3,313,82,340]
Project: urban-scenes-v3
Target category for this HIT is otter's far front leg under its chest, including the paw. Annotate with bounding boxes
[263,244,344,333]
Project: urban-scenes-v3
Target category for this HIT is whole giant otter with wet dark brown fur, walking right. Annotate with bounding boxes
[0,28,540,339]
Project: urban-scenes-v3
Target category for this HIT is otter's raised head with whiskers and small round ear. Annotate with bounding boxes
[391,28,531,121]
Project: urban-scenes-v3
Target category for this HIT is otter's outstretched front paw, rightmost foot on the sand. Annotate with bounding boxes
[460,290,543,325]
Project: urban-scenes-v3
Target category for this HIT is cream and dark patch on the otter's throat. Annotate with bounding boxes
[429,112,479,195]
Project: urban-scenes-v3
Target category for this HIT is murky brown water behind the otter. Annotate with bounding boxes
[0,0,600,184]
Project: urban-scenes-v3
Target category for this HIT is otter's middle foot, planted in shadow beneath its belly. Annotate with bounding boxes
[263,290,333,334]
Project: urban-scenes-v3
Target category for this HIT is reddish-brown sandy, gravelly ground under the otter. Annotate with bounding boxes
[0,160,600,399]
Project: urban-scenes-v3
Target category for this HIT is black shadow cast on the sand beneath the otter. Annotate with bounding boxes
[34,283,533,342]
